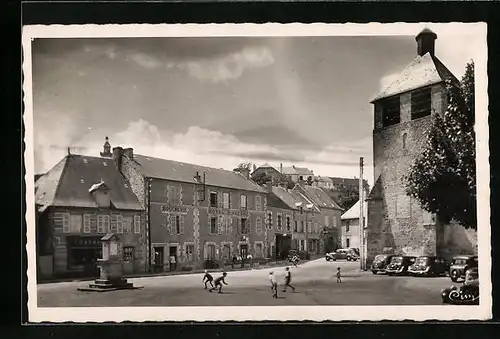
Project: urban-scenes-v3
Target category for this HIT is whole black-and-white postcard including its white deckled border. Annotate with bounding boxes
[23,23,492,322]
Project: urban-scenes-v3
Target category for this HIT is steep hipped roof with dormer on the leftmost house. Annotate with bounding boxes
[35,154,142,211]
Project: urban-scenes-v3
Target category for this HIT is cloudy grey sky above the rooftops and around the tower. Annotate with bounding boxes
[32,27,476,186]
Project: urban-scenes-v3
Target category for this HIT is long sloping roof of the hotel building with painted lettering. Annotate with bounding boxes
[134,154,266,193]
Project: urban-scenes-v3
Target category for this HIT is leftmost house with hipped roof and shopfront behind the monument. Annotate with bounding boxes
[35,154,147,280]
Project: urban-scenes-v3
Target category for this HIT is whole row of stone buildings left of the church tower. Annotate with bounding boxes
[35,138,343,278]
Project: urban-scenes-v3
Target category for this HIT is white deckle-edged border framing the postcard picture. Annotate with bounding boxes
[22,23,492,322]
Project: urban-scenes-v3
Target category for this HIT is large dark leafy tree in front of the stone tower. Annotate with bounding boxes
[404,62,477,229]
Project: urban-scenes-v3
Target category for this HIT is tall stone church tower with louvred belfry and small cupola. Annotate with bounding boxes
[366,29,475,263]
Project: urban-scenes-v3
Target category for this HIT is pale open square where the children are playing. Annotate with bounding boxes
[38,259,460,307]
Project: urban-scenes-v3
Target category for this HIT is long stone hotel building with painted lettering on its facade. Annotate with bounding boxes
[113,147,267,271]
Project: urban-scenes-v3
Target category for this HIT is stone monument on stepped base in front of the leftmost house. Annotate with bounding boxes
[78,234,142,292]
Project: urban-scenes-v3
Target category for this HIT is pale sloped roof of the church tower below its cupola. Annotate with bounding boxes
[371,53,458,103]
